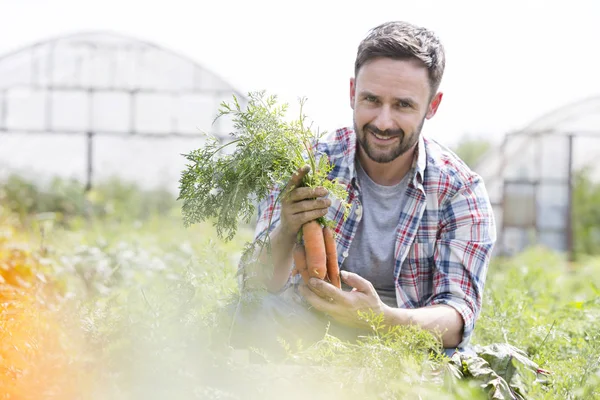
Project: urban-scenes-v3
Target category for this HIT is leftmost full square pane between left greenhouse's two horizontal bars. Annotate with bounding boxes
[6,89,47,130]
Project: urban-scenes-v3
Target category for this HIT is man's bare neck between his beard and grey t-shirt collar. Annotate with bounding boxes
[357,144,417,186]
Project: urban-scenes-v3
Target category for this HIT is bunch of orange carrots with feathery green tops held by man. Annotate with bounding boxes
[178,91,349,287]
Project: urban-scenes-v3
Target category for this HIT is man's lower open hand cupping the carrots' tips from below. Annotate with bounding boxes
[299,271,387,328]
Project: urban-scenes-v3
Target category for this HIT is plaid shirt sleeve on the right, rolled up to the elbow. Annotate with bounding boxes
[430,175,496,347]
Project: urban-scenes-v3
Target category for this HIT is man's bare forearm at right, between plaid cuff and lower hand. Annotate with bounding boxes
[384,304,464,348]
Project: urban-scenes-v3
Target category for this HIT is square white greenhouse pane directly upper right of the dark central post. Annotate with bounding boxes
[91,92,131,133]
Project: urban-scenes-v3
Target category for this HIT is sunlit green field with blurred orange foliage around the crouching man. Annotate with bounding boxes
[0,177,600,400]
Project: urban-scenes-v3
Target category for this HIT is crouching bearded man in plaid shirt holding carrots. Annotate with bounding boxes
[237,22,496,354]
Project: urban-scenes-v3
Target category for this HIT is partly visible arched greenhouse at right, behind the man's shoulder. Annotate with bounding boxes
[474,96,600,255]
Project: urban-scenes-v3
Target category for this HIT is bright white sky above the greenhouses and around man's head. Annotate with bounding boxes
[0,0,600,148]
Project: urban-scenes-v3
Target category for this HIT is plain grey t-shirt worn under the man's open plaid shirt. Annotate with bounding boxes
[341,160,409,307]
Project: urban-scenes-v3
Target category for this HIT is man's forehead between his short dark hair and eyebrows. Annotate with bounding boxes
[356,58,429,99]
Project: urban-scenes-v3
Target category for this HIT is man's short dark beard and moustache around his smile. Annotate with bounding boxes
[354,118,425,164]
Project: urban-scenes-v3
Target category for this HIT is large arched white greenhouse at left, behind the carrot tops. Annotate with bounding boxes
[0,29,246,191]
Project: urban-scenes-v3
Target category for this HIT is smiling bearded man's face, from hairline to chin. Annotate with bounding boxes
[350,58,442,163]
